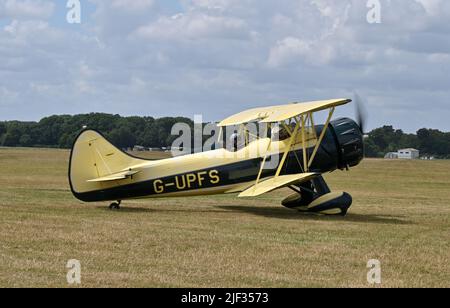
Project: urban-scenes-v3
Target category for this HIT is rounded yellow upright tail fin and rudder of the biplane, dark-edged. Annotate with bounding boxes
[69,130,144,196]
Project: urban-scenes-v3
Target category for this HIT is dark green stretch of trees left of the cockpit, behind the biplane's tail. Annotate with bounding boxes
[0,113,194,149]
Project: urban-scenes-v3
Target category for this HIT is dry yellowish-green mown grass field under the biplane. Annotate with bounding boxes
[0,148,450,287]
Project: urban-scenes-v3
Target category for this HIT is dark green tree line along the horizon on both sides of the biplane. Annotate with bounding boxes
[0,113,450,159]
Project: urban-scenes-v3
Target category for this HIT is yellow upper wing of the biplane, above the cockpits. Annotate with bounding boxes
[219,98,352,126]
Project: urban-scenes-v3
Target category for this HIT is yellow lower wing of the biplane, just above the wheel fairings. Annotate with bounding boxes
[239,173,320,198]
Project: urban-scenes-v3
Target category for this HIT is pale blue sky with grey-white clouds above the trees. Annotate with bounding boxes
[0,0,450,132]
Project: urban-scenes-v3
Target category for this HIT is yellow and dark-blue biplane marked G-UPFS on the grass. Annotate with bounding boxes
[69,99,364,215]
